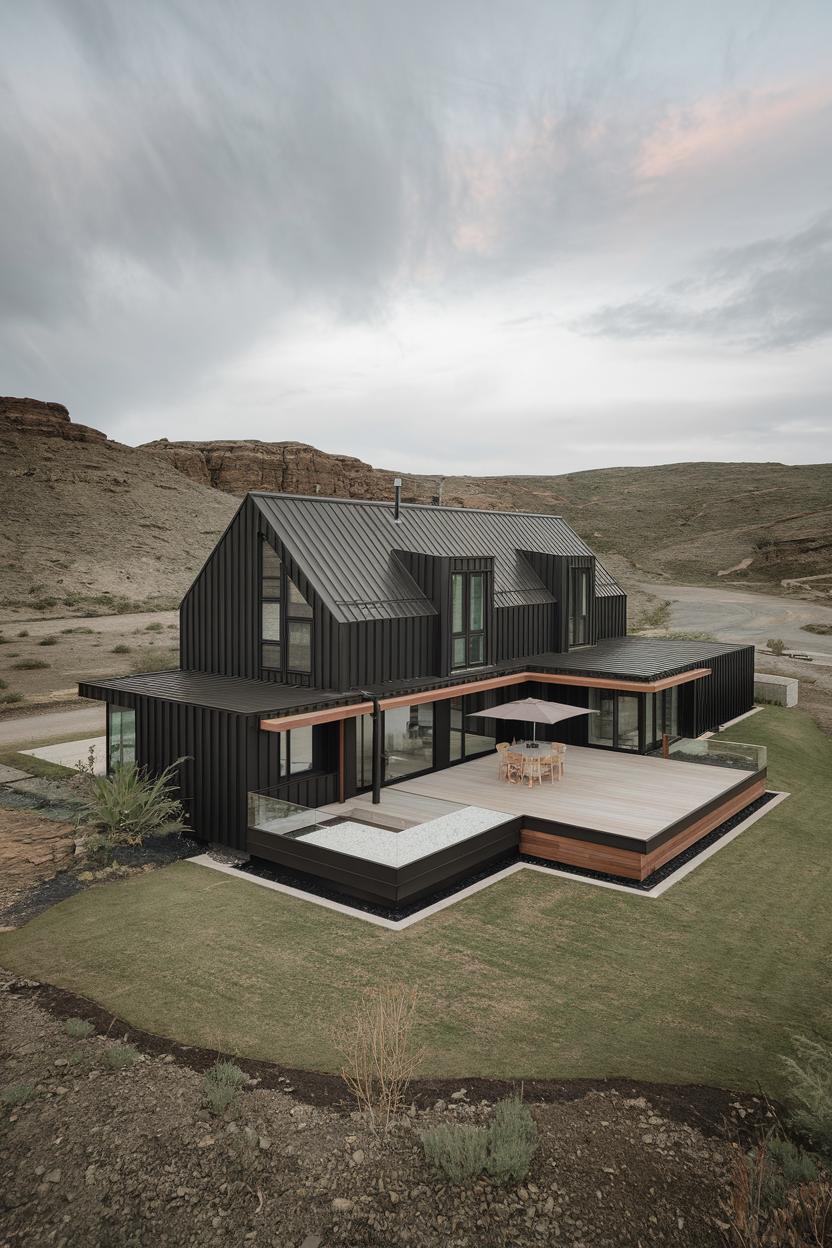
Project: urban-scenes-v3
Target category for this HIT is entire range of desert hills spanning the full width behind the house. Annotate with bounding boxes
[0,398,832,610]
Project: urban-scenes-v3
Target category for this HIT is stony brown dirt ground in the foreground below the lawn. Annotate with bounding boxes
[0,975,763,1248]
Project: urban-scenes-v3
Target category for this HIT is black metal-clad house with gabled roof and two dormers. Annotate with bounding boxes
[79,493,753,849]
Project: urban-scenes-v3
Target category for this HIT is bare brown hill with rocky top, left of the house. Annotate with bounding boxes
[0,398,237,609]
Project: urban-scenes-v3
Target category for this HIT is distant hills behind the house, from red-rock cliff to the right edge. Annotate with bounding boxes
[146,441,832,594]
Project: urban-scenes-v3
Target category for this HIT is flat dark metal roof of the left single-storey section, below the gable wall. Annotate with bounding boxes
[79,669,356,715]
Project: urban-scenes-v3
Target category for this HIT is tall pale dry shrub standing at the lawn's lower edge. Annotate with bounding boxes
[336,983,422,1133]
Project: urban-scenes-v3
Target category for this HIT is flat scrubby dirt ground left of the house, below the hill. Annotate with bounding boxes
[0,609,178,713]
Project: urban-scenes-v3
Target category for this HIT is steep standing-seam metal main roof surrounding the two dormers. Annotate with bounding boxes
[251,493,624,623]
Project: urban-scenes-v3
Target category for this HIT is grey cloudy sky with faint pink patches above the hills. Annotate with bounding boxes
[0,0,832,473]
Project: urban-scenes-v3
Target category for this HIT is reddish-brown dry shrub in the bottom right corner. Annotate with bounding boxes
[725,1139,832,1248]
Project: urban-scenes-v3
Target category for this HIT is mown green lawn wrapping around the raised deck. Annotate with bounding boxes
[0,708,832,1094]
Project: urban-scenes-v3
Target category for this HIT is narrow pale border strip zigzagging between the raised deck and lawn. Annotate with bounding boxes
[185,790,791,932]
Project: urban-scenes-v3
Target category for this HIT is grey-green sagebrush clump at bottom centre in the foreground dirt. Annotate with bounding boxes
[422,1097,538,1183]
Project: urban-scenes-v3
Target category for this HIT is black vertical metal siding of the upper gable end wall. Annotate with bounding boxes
[180,498,339,689]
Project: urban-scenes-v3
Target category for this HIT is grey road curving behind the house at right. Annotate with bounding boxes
[641,584,832,665]
